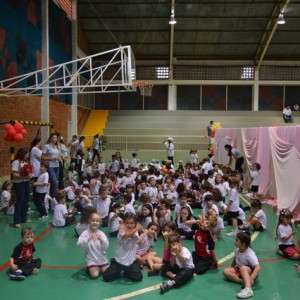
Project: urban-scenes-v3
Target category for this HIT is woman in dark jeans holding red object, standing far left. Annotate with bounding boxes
[11,148,32,228]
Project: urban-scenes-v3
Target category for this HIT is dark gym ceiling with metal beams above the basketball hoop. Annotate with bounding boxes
[77,0,300,65]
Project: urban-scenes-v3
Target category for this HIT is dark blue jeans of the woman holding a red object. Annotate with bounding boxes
[14,180,30,224]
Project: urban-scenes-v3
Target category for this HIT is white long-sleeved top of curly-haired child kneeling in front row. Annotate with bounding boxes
[77,229,109,266]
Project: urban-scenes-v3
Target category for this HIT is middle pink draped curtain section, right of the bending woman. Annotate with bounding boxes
[241,127,271,195]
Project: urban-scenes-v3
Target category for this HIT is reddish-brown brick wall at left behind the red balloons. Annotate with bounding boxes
[0,96,71,183]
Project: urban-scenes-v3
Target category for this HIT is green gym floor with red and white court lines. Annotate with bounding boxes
[0,196,300,300]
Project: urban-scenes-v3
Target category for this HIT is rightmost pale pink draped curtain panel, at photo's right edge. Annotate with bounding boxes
[269,126,300,210]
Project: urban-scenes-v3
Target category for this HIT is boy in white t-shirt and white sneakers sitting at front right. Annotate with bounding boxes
[223,232,260,299]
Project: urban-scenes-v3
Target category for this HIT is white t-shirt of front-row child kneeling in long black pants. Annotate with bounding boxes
[115,229,139,266]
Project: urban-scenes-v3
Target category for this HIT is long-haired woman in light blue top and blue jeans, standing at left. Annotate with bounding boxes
[42,132,62,197]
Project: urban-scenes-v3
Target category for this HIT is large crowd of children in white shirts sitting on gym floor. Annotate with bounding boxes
[1,151,300,298]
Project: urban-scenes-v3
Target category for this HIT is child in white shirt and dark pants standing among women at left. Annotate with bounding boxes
[33,161,50,220]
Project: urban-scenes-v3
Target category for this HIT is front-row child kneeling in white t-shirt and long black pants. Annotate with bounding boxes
[103,213,143,282]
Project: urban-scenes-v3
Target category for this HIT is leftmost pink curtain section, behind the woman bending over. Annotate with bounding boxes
[214,128,242,165]
